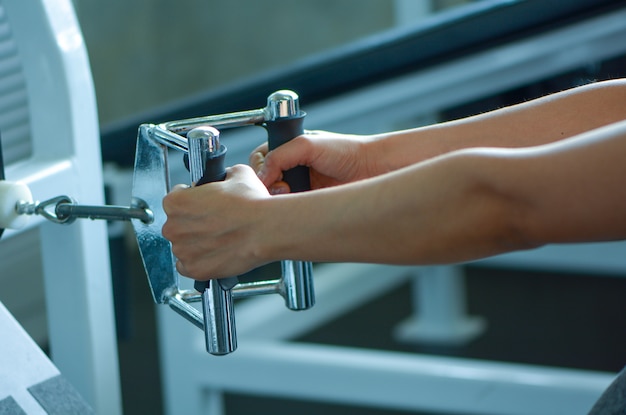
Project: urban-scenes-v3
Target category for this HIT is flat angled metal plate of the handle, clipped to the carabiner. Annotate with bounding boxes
[131,125,178,303]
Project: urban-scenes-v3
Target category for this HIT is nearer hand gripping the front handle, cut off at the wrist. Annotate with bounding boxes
[163,165,270,280]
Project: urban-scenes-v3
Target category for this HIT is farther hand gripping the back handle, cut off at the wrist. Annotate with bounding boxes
[250,131,380,194]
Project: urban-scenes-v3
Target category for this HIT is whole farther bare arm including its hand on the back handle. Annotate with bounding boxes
[250,80,626,191]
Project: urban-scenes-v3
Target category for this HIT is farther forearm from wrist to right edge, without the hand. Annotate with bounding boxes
[370,80,626,171]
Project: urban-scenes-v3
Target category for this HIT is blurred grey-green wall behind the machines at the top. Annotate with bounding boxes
[73,0,471,126]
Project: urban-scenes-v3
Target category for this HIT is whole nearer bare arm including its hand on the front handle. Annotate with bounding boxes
[163,122,626,279]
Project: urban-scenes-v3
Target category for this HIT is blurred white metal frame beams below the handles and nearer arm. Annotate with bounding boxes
[158,264,613,415]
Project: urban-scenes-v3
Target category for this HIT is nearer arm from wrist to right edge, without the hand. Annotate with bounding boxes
[263,121,626,264]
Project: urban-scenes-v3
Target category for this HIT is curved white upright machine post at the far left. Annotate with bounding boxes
[3,0,121,414]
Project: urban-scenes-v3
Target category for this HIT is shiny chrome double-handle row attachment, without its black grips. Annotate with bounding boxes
[131,90,315,355]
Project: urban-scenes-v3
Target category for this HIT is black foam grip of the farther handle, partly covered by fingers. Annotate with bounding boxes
[264,111,311,193]
